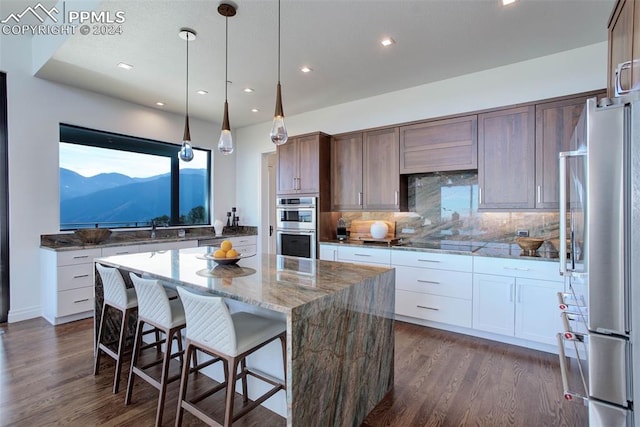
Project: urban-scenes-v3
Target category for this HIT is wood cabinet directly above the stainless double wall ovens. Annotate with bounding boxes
[276,132,330,200]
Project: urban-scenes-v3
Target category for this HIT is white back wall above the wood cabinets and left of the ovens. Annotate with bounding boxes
[236,42,607,229]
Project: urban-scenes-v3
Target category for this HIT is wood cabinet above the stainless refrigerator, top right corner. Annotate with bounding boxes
[607,0,640,97]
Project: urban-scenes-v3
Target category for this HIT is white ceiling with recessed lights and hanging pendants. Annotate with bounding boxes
[23,0,614,128]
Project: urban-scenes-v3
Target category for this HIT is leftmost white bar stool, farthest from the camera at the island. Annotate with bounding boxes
[93,264,138,394]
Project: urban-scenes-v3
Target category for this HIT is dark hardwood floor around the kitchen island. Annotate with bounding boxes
[0,319,587,427]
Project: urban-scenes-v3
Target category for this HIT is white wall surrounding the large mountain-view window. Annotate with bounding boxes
[0,36,235,322]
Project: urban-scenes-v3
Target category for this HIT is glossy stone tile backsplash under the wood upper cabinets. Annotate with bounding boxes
[332,171,559,243]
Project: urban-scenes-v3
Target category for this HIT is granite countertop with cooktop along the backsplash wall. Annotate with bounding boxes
[320,240,558,261]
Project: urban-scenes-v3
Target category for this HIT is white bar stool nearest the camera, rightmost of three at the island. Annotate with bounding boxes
[176,287,287,427]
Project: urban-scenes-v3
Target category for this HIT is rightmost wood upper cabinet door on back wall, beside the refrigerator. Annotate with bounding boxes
[535,97,587,209]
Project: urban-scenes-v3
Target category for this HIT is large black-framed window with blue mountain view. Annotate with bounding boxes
[60,124,211,230]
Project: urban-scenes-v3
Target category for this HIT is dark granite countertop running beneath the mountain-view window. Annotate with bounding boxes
[40,226,258,251]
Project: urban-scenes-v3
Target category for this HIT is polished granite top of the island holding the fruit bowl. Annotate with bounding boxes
[96,247,390,314]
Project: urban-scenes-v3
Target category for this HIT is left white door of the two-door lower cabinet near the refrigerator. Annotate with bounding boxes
[473,274,515,336]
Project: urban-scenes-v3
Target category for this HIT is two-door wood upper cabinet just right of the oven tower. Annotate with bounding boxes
[331,128,405,211]
